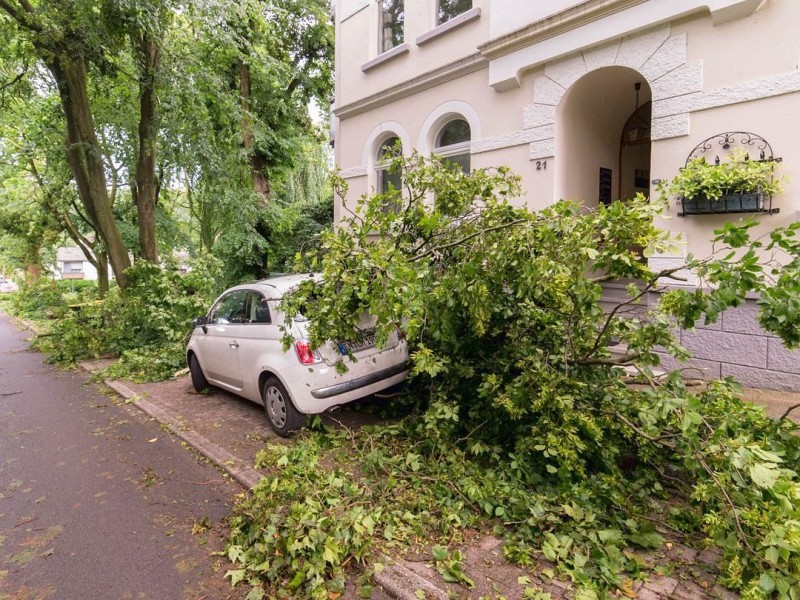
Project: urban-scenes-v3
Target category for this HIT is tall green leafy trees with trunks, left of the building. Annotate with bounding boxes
[0,0,333,288]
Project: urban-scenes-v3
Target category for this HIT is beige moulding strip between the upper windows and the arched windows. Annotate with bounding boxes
[333,54,489,119]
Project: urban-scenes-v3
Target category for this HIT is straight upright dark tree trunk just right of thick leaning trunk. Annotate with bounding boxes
[134,33,159,263]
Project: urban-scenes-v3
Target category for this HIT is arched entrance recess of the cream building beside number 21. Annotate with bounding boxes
[555,67,652,206]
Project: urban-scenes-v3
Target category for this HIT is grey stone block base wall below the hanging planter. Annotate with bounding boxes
[661,300,800,392]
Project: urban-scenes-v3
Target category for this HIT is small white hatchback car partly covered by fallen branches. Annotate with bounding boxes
[186,275,409,436]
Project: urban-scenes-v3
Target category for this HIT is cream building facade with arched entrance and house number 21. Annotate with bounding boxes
[332,0,800,390]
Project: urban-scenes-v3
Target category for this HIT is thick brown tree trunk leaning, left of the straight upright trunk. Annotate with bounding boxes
[48,49,131,289]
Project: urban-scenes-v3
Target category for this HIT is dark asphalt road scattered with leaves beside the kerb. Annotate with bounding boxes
[0,314,246,600]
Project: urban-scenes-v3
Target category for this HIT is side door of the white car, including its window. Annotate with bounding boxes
[200,290,248,391]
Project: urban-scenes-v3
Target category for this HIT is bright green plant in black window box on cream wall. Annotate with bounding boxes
[669,151,782,214]
